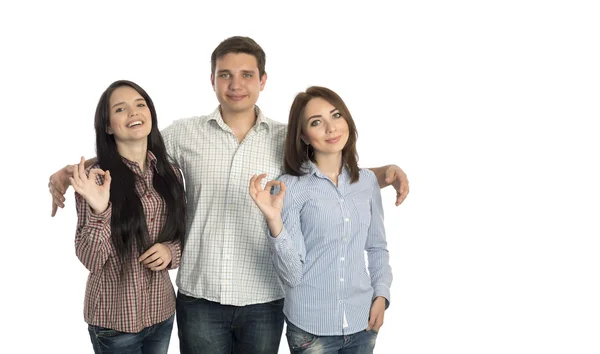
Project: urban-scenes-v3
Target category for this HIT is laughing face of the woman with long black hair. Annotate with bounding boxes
[107,86,152,142]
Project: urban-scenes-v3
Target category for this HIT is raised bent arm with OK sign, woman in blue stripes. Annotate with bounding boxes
[250,174,306,287]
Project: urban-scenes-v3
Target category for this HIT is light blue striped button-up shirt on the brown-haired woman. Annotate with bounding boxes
[269,163,392,336]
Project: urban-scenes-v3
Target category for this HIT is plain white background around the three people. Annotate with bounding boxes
[0,0,600,354]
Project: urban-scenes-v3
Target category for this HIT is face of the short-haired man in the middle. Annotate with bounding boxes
[210,53,267,114]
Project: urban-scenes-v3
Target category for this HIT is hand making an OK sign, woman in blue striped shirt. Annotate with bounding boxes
[249,173,286,220]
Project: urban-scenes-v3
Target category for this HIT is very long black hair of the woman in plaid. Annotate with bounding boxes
[94,80,185,264]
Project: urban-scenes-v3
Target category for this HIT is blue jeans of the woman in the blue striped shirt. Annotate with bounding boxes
[285,321,377,354]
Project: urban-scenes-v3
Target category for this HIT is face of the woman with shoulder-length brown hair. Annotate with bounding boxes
[302,97,349,157]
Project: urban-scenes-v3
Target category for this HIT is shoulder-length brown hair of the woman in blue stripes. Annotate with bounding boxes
[284,86,359,183]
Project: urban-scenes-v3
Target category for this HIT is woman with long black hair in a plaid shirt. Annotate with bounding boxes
[70,80,185,354]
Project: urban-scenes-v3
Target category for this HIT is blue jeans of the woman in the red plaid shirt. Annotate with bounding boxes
[88,315,175,354]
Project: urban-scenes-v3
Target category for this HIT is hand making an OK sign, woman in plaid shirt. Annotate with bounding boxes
[69,156,111,214]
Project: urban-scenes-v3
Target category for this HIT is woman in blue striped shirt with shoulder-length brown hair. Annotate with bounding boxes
[249,86,392,354]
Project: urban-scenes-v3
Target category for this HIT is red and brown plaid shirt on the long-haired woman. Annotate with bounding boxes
[75,151,181,333]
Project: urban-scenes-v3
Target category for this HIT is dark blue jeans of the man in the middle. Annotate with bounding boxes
[177,292,284,354]
